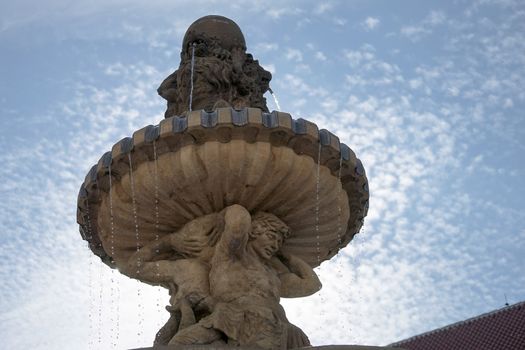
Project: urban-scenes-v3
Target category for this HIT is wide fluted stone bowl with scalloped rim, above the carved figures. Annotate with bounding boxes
[77,108,369,276]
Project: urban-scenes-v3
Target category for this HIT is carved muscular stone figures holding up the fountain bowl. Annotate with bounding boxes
[129,205,321,349]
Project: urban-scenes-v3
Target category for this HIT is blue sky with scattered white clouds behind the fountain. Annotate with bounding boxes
[0,0,525,349]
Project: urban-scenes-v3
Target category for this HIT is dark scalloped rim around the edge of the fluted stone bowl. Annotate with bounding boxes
[77,108,369,268]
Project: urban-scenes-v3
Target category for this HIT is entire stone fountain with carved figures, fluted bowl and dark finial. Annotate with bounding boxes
[77,16,398,349]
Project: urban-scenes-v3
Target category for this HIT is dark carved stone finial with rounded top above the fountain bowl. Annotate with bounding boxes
[157,15,272,118]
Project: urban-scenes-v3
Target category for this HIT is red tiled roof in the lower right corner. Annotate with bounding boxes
[390,301,525,350]
